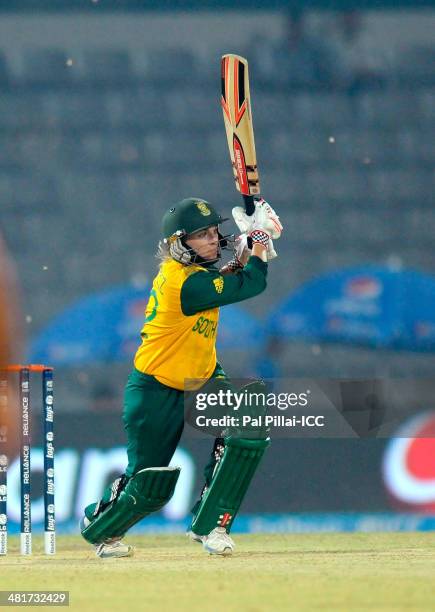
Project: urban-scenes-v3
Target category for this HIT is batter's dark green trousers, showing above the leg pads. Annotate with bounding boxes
[85,364,229,519]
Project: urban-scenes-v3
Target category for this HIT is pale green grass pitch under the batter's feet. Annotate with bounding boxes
[0,533,435,612]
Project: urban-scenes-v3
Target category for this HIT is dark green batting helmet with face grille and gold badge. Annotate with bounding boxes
[162,198,232,265]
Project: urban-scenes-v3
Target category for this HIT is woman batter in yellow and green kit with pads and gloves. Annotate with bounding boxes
[80,198,282,558]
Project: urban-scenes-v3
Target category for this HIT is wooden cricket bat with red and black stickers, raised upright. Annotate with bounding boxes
[221,53,260,215]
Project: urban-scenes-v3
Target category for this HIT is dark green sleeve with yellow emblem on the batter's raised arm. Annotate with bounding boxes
[181,256,267,316]
